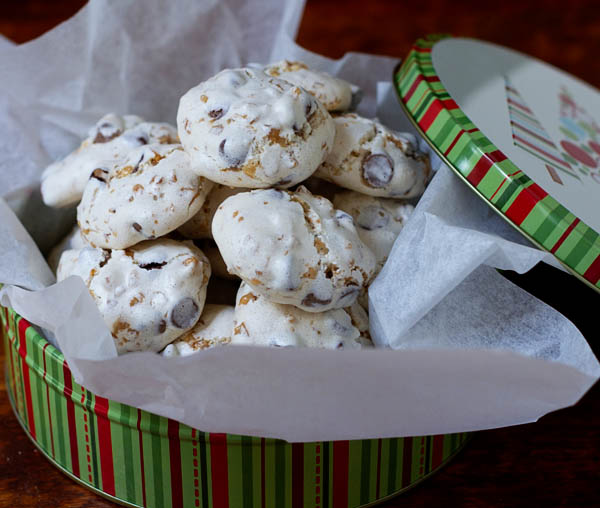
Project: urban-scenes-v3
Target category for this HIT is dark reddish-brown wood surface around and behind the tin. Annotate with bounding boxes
[0,0,600,508]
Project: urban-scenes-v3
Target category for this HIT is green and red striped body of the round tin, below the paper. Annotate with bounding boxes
[0,307,467,508]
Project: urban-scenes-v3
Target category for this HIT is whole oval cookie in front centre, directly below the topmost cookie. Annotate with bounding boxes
[212,186,375,313]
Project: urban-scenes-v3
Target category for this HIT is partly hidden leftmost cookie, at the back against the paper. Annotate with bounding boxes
[41,113,179,207]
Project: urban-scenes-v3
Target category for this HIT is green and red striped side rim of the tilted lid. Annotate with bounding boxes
[394,35,600,291]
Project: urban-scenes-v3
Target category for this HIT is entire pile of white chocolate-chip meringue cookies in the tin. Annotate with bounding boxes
[42,61,430,356]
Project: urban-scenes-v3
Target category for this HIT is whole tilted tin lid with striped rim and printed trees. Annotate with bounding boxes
[394,35,600,292]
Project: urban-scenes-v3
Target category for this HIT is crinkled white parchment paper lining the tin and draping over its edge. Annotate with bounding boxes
[0,0,600,441]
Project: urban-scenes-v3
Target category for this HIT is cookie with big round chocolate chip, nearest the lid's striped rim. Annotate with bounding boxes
[315,113,431,198]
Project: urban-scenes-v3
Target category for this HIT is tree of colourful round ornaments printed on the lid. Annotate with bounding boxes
[558,86,600,184]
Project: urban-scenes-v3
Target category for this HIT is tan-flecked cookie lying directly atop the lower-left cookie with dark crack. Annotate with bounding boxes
[77,144,214,249]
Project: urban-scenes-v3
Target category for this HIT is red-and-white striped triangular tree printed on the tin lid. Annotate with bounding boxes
[504,76,580,185]
